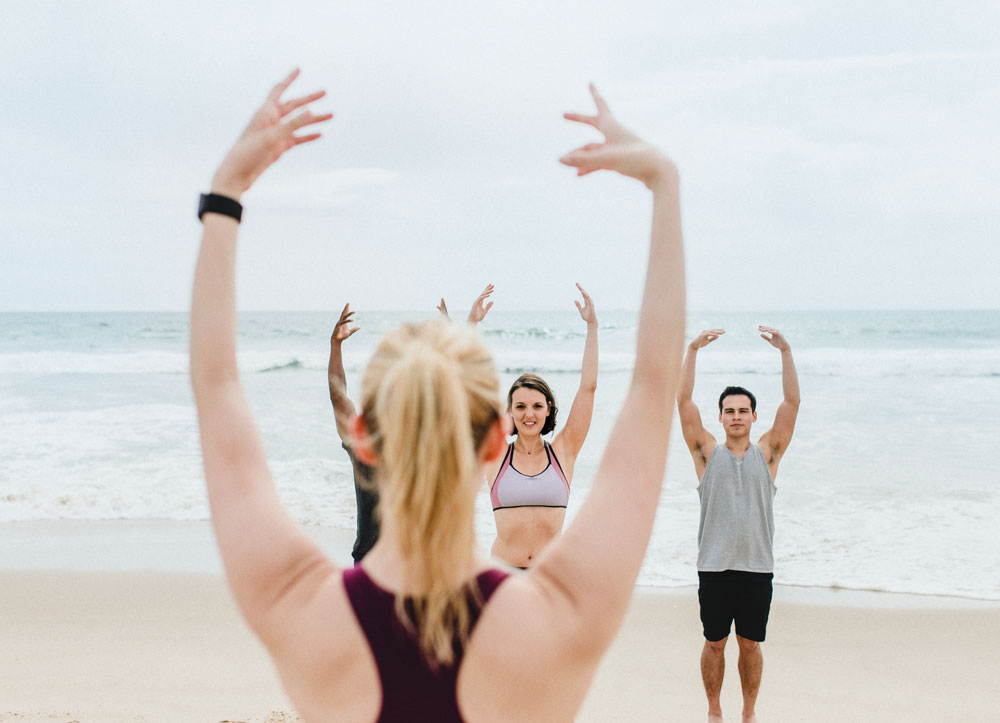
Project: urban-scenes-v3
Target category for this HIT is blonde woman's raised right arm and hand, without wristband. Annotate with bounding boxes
[528,86,684,657]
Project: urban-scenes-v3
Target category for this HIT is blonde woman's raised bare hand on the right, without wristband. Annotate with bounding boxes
[559,83,677,188]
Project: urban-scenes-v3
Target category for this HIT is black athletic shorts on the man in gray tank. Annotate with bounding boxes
[698,570,774,643]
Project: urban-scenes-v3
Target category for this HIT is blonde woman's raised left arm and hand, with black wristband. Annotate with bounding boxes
[190,70,332,642]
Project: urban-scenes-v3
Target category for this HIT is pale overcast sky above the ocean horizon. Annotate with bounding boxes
[0,0,1000,311]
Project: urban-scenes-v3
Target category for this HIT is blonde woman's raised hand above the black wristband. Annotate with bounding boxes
[212,68,333,199]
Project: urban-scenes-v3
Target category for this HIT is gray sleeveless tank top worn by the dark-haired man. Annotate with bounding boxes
[698,444,777,572]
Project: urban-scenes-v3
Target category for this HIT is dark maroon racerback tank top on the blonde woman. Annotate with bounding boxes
[344,565,507,723]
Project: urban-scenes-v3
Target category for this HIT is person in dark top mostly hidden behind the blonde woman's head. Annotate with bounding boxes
[327,304,378,563]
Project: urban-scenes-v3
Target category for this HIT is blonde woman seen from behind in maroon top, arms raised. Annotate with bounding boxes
[190,71,685,723]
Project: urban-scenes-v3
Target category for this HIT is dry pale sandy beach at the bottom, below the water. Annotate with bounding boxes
[0,571,1000,723]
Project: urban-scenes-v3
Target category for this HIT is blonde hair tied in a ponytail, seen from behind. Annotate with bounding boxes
[361,320,499,665]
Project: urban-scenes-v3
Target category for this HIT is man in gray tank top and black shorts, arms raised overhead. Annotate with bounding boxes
[677,326,799,723]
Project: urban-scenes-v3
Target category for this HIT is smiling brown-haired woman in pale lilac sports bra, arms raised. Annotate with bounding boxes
[480,284,597,568]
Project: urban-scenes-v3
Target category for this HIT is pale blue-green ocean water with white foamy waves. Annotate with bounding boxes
[0,310,1000,600]
